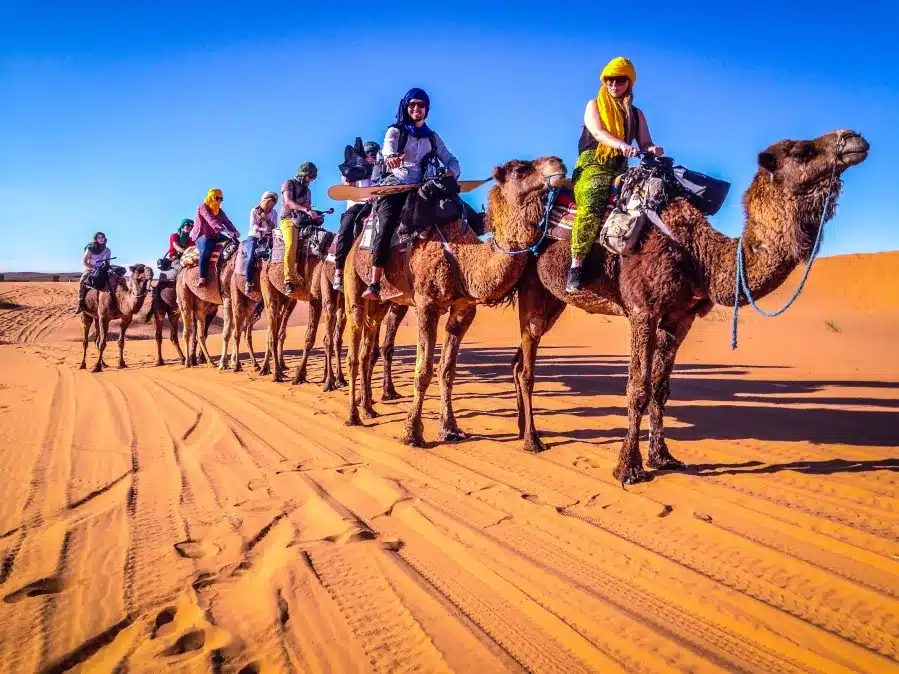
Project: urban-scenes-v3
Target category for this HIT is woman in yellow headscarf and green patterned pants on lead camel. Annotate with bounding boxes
[565,56,664,293]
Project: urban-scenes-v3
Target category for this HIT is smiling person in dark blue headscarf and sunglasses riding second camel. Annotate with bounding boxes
[362,88,460,301]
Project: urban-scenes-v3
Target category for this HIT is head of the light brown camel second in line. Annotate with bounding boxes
[487,156,568,236]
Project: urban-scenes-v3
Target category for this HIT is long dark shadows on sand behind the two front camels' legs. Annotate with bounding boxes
[376,345,899,462]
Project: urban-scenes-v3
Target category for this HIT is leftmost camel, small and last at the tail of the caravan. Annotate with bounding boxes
[79,264,153,372]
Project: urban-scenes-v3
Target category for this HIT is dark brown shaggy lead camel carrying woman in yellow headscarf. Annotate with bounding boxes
[512,131,869,484]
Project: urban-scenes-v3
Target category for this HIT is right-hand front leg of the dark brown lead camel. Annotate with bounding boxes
[646,314,696,470]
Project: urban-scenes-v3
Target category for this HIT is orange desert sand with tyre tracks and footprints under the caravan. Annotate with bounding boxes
[0,253,899,674]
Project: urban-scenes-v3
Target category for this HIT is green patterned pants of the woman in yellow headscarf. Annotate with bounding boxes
[571,150,627,257]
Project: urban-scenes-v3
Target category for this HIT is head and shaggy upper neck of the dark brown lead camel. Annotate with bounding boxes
[743,130,869,260]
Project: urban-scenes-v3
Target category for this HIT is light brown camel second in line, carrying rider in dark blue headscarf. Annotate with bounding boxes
[344,157,566,447]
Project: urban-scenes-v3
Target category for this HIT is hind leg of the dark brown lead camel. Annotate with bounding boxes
[512,279,566,453]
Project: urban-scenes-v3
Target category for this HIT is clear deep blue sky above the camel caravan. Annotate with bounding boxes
[0,0,899,271]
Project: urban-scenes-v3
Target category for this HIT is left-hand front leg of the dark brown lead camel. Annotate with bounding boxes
[612,313,658,484]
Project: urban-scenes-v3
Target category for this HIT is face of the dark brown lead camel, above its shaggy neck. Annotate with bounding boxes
[759,130,870,194]
